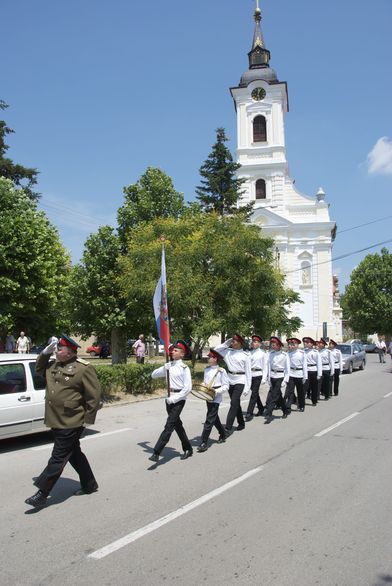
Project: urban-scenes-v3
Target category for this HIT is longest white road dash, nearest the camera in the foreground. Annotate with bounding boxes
[87,466,264,560]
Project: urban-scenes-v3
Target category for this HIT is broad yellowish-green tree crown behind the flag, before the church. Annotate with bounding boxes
[120,210,301,358]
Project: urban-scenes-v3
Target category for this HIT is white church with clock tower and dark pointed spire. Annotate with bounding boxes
[230,0,342,341]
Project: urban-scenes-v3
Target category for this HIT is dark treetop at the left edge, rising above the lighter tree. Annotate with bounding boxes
[0,100,39,200]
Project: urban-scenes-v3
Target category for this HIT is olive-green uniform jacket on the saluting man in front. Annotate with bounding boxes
[35,354,101,429]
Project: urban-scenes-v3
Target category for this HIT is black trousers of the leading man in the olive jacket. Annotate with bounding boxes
[34,427,96,494]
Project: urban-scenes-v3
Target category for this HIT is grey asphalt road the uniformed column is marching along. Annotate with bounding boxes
[0,355,392,586]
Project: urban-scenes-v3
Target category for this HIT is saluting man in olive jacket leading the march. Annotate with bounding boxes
[25,334,101,508]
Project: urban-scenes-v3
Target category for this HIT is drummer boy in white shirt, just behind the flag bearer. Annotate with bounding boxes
[197,349,229,452]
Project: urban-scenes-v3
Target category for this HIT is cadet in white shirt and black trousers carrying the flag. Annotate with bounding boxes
[149,340,193,462]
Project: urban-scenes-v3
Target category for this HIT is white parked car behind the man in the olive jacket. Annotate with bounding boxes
[0,354,48,439]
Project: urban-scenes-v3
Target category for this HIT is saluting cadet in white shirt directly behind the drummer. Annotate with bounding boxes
[215,334,252,436]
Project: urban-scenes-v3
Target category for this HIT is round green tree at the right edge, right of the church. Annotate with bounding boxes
[342,248,392,337]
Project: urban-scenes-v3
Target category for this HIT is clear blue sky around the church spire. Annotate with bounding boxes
[0,0,392,289]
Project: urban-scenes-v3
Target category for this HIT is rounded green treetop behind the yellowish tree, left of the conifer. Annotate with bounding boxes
[117,167,184,247]
